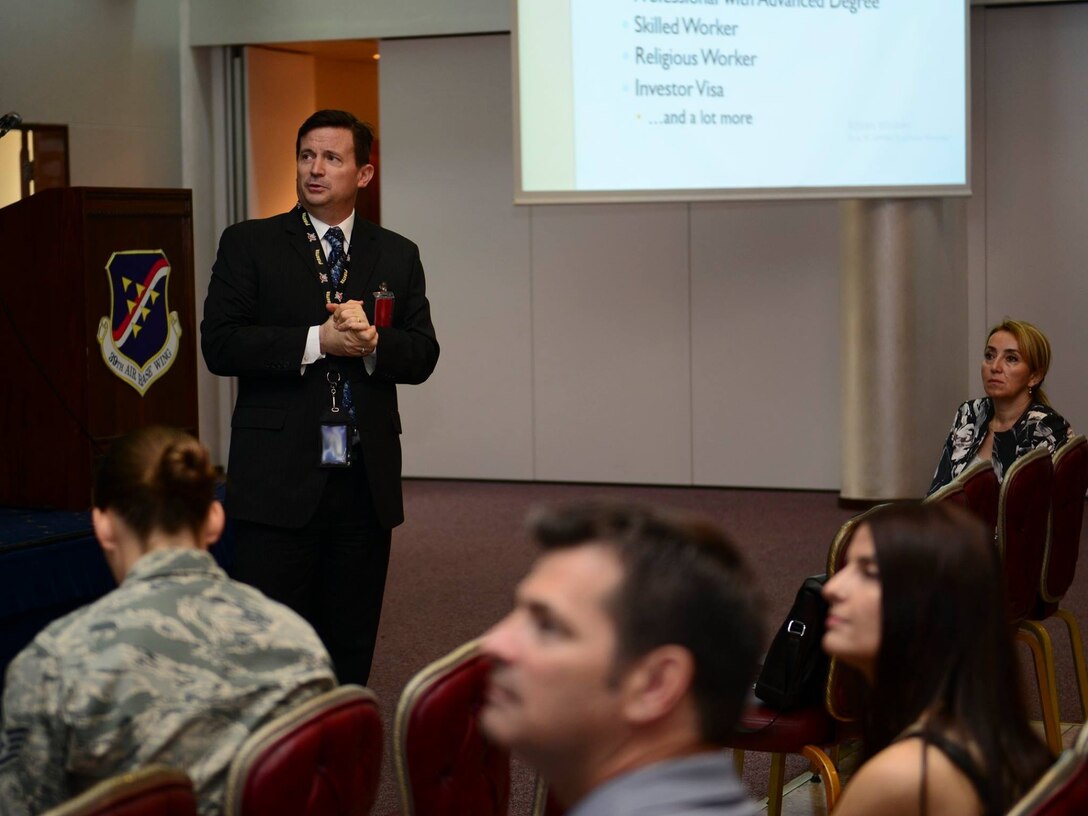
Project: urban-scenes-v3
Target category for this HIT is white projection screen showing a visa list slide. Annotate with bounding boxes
[512,0,970,203]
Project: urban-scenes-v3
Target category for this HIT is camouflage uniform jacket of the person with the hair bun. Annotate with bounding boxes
[0,549,335,816]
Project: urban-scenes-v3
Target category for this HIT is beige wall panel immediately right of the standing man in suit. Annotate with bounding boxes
[378,37,534,479]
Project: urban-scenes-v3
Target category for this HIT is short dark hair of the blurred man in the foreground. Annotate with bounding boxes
[529,502,764,745]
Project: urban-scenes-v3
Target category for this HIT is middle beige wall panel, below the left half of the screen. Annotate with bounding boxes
[532,205,691,484]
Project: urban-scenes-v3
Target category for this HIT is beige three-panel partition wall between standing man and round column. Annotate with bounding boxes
[381,36,839,487]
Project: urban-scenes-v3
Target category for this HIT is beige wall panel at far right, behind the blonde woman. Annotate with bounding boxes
[983,3,1088,432]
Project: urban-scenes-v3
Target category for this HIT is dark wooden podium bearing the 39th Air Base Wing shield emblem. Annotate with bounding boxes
[0,187,197,510]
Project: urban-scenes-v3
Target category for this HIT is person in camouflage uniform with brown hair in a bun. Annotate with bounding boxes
[0,429,335,816]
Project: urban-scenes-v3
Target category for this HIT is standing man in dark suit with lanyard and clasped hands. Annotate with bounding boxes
[200,111,438,683]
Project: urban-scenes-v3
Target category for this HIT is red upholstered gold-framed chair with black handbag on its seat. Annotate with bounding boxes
[727,505,882,816]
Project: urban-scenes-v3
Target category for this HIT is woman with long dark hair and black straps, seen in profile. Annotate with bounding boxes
[824,505,1052,816]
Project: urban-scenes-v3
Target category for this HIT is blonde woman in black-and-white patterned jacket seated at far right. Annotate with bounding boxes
[929,318,1073,493]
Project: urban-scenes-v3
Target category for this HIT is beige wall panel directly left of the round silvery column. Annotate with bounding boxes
[692,201,839,489]
